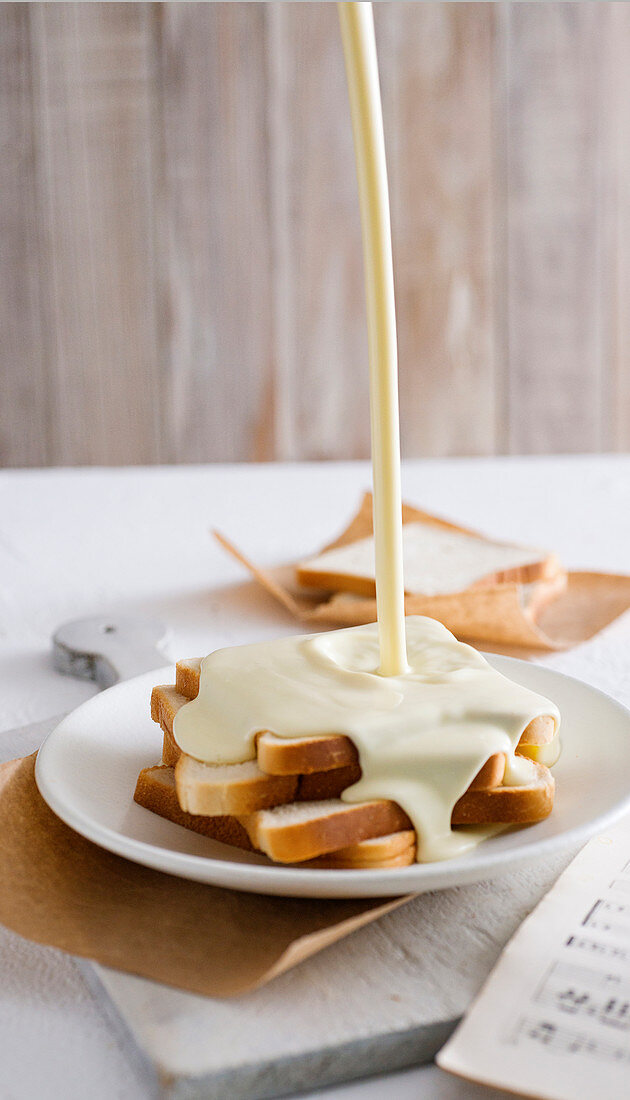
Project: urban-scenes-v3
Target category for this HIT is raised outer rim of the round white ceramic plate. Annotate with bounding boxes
[35,653,630,898]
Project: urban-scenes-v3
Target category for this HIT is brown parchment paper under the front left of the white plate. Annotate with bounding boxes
[0,755,408,997]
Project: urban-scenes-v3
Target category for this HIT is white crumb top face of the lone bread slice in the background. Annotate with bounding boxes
[300,523,546,596]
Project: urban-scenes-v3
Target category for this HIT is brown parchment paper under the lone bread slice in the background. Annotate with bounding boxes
[214,493,630,656]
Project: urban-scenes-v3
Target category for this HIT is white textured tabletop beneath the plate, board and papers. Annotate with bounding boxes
[0,457,630,1100]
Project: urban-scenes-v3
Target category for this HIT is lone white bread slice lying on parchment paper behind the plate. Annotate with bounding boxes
[296,517,561,596]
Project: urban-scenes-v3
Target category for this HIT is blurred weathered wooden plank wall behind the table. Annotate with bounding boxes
[0,2,630,465]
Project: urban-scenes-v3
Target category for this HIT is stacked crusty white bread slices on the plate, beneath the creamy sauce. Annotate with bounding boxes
[134,659,555,869]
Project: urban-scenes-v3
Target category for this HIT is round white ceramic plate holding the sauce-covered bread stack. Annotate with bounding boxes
[35,656,630,898]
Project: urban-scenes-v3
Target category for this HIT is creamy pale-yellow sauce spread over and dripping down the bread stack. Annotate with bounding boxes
[174,616,560,861]
